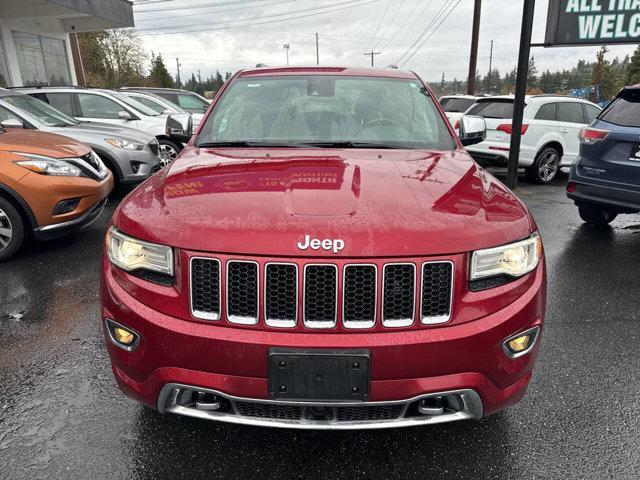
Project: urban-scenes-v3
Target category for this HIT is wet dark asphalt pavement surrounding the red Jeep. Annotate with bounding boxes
[0,173,640,480]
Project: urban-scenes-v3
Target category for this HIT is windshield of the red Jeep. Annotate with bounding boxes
[196,75,455,150]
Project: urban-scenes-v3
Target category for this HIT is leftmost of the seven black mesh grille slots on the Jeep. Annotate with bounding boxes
[191,258,220,319]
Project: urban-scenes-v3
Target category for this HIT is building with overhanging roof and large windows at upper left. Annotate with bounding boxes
[0,0,134,87]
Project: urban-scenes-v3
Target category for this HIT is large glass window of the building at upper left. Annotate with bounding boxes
[13,32,71,86]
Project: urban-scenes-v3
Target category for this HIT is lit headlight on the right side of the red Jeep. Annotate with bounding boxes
[470,234,542,281]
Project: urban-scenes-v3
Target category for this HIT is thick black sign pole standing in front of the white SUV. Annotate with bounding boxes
[507,0,536,190]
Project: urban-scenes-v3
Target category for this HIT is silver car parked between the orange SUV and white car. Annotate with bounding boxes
[0,90,160,185]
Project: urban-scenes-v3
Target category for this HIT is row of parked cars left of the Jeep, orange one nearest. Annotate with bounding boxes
[0,87,208,261]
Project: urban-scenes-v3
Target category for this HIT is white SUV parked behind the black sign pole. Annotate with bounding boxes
[465,95,601,183]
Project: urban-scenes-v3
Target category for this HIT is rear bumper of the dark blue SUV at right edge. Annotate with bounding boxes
[567,159,640,213]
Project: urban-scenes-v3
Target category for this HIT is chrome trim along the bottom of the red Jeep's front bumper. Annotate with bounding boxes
[157,383,483,430]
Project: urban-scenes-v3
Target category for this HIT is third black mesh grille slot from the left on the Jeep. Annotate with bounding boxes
[265,263,298,322]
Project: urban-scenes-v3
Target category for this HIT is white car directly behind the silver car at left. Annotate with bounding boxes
[19,87,182,165]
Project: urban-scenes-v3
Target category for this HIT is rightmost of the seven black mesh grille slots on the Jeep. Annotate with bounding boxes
[422,263,453,321]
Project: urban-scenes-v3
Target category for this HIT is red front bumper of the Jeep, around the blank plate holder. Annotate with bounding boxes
[102,262,546,429]
